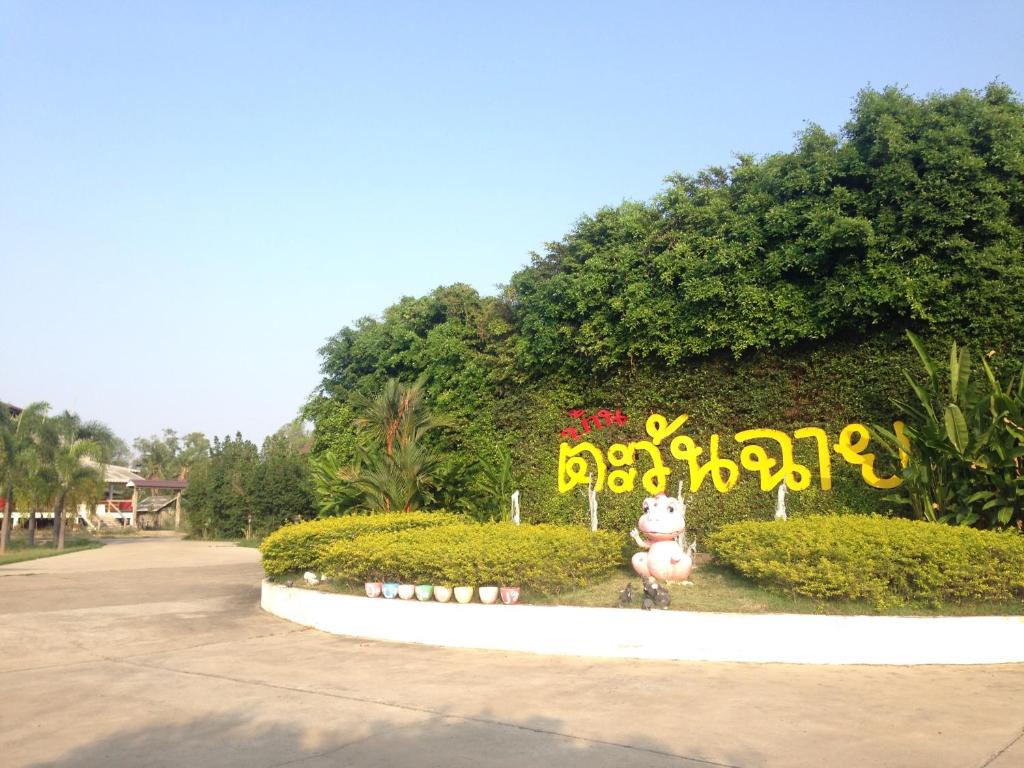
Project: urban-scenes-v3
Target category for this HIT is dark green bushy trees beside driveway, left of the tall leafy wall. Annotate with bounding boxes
[184,433,313,539]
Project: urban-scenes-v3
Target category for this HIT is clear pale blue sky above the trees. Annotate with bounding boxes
[0,0,1024,442]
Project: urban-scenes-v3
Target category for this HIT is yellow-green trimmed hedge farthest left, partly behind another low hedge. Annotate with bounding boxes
[259,512,465,578]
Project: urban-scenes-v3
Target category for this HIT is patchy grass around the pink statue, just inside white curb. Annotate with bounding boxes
[292,564,1024,615]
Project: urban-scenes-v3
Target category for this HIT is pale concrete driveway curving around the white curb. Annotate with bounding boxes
[0,540,1024,768]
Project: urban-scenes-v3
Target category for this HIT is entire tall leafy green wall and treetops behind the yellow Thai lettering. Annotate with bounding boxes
[306,84,1024,536]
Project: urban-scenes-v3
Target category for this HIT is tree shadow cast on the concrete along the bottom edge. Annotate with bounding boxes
[25,707,763,768]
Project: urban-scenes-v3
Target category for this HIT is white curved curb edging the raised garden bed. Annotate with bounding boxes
[261,581,1024,665]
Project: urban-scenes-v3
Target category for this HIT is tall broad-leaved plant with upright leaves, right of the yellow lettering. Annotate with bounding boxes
[876,334,1024,527]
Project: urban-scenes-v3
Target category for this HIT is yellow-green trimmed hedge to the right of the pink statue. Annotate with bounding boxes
[708,515,1024,609]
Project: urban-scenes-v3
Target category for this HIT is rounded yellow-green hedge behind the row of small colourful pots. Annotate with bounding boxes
[321,523,623,594]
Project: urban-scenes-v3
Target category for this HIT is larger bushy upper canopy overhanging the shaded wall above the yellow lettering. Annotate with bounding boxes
[511,86,1024,371]
